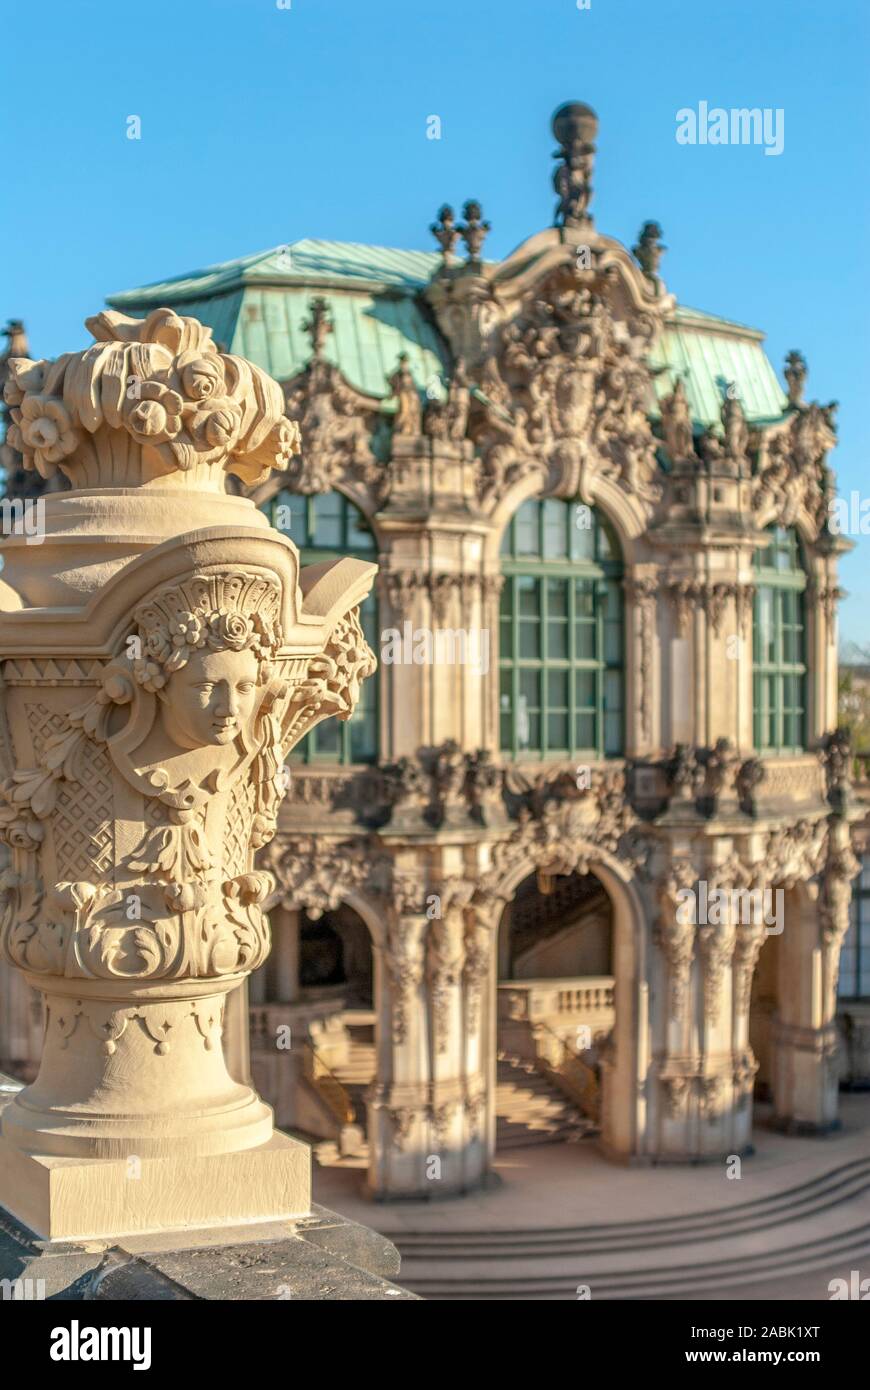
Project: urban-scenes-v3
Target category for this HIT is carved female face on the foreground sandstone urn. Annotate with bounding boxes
[160,648,260,748]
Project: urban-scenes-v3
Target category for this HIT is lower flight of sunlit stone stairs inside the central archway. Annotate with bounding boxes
[495,1051,595,1152]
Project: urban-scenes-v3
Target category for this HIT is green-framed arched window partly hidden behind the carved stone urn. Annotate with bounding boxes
[264,492,378,763]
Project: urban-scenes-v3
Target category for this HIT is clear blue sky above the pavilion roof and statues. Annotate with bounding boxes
[6,0,870,642]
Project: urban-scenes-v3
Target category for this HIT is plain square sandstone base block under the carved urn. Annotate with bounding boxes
[0,1133,311,1241]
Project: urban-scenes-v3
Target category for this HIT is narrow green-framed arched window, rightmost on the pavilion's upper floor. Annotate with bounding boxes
[752,525,806,753]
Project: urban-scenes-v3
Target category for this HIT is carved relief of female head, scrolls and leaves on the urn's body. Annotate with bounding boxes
[0,558,374,980]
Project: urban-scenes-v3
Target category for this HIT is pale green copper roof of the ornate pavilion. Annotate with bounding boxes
[108,239,787,425]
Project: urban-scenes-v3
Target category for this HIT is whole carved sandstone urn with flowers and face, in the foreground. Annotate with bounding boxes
[0,309,375,1240]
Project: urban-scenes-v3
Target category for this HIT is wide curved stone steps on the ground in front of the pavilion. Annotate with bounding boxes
[392,1156,870,1301]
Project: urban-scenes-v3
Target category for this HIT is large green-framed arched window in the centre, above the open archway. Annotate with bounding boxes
[499,498,625,759]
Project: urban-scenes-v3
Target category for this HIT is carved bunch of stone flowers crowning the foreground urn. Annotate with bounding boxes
[4,309,300,488]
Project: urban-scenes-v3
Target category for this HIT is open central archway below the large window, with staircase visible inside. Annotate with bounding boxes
[495,870,616,1151]
